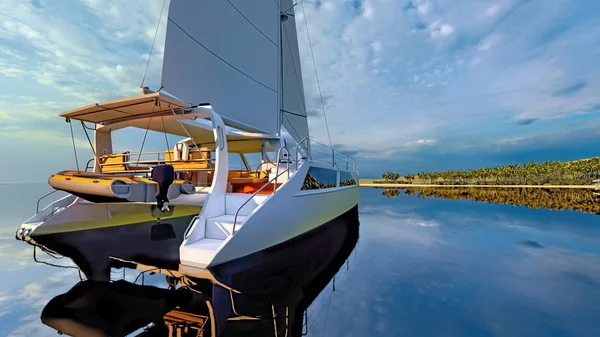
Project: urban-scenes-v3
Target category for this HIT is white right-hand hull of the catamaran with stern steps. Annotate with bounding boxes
[180,163,358,277]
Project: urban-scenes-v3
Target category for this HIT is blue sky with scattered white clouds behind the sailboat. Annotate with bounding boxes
[0,0,600,182]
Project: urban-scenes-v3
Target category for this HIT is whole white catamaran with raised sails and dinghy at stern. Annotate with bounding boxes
[16,0,358,285]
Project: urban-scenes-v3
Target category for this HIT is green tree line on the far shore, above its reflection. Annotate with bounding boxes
[380,157,600,185]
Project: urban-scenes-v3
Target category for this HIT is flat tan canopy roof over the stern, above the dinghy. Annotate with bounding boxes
[60,92,190,124]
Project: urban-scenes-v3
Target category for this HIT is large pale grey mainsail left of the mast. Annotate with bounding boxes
[161,0,280,134]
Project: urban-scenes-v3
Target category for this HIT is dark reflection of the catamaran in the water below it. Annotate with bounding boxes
[41,203,359,337]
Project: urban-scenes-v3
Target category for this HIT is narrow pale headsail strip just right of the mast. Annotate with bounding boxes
[281,0,308,141]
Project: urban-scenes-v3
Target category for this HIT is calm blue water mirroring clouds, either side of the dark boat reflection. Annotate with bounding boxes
[0,184,600,337]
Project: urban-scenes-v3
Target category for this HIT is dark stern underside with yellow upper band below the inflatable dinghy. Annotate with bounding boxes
[29,205,200,281]
